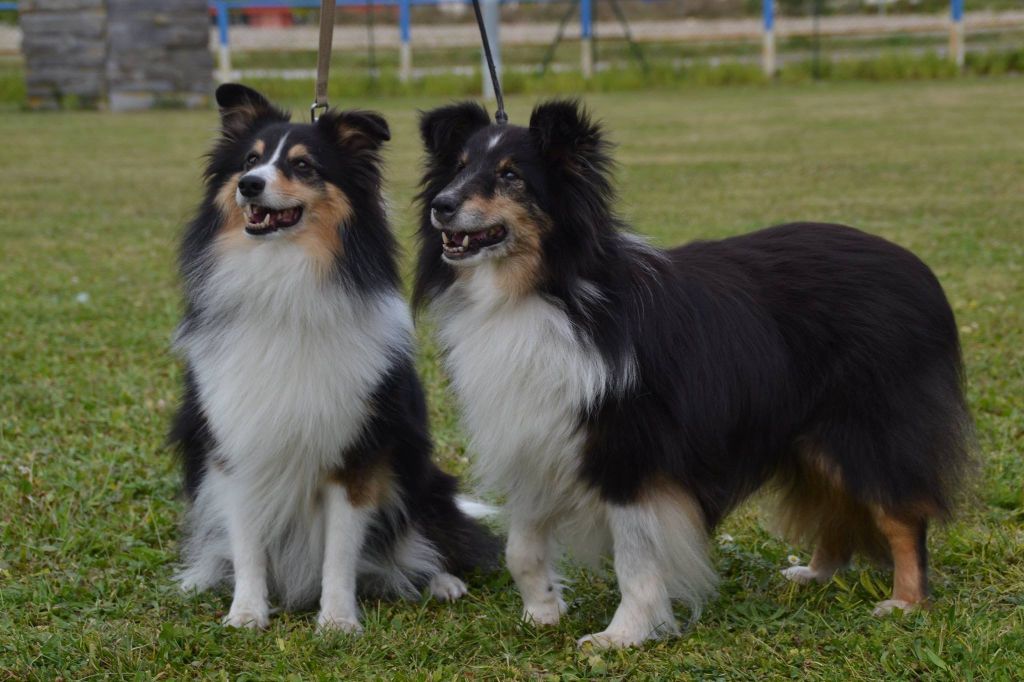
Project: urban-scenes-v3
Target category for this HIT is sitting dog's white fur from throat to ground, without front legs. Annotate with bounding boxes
[175,240,416,603]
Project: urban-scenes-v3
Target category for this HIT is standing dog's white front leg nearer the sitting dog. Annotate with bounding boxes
[505,517,566,625]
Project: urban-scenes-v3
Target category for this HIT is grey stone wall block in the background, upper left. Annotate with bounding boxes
[18,0,213,111]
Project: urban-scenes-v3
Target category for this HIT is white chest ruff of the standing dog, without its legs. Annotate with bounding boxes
[434,263,617,560]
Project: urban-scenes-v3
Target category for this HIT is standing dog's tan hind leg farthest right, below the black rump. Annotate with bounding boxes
[873,509,928,615]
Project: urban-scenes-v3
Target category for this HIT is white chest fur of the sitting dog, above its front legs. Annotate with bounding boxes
[177,240,412,497]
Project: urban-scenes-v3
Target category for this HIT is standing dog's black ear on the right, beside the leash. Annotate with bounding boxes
[529,99,608,171]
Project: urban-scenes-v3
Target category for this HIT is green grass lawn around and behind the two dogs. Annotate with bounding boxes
[0,79,1024,680]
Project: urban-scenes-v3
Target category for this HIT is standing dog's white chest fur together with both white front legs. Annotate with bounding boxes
[434,262,715,630]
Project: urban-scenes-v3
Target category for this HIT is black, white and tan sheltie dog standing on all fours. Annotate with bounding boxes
[416,101,971,646]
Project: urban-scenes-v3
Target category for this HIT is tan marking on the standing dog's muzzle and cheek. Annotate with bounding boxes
[463,195,549,298]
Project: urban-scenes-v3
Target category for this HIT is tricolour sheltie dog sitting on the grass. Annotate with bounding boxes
[170,85,498,632]
